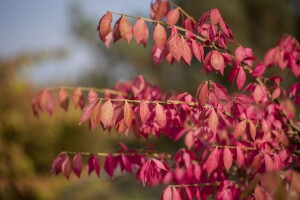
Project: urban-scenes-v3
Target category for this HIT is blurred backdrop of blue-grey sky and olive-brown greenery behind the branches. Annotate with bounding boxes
[0,0,300,199]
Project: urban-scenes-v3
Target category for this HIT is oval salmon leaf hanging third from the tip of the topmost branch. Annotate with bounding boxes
[133,18,149,46]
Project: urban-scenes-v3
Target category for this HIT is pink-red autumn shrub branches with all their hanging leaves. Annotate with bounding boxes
[32,0,300,200]
